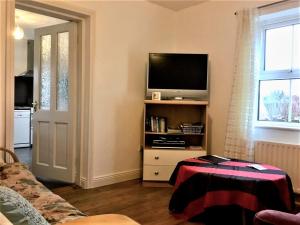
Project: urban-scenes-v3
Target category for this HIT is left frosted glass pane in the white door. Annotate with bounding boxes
[40,35,51,110]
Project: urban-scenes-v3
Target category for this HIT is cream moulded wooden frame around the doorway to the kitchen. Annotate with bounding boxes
[6,0,96,188]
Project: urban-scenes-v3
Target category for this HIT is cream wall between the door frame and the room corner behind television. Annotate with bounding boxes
[72,1,175,185]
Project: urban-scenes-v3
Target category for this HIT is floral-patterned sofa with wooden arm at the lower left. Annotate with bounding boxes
[0,148,138,225]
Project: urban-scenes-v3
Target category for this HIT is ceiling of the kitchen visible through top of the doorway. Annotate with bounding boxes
[15,9,68,29]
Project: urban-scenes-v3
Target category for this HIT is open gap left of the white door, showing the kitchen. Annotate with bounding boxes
[13,8,68,174]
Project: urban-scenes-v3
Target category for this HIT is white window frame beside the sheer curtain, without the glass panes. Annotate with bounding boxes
[255,12,300,130]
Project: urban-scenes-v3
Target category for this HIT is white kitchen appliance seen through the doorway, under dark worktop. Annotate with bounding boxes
[14,109,30,148]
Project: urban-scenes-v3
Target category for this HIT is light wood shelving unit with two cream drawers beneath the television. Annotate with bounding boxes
[143,100,208,181]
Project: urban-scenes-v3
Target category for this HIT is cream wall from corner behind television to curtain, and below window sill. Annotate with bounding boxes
[176,1,300,155]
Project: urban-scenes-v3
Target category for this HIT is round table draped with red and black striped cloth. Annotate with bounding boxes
[169,158,294,220]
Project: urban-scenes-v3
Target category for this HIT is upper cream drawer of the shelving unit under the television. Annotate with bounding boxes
[144,150,206,166]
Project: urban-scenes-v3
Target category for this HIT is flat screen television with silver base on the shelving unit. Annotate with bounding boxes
[146,53,208,99]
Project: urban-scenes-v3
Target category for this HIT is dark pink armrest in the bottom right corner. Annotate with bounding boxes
[254,210,300,225]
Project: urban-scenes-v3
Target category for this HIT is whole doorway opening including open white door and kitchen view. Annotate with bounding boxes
[14,9,78,186]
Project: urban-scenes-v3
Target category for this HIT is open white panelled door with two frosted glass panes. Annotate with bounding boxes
[32,22,77,182]
